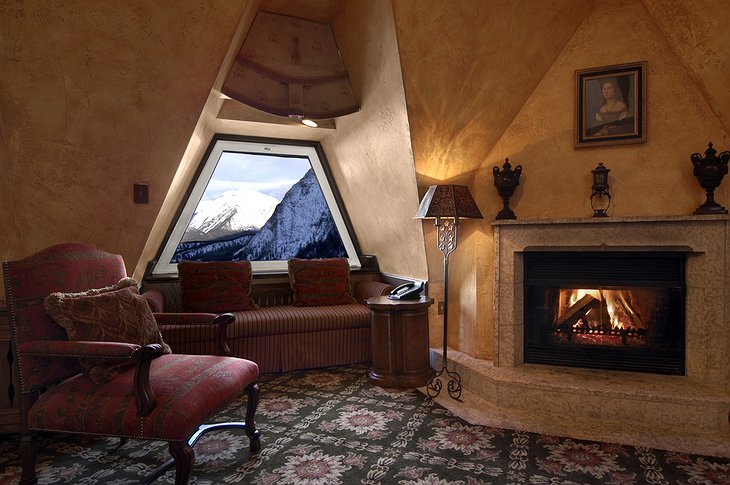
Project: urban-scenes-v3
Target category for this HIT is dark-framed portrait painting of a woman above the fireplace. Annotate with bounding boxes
[575,62,646,148]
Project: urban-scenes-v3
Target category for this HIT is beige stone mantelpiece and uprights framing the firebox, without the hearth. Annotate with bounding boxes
[492,215,730,390]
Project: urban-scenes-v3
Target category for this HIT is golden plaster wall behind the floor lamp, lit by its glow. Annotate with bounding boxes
[393,0,590,358]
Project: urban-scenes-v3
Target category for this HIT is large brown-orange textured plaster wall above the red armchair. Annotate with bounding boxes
[0,0,245,294]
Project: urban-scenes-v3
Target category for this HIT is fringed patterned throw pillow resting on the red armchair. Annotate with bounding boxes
[44,278,171,384]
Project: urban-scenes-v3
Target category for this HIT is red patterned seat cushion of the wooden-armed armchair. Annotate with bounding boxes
[28,354,258,441]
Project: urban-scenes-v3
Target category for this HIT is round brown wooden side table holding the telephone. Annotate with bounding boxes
[366,296,433,388]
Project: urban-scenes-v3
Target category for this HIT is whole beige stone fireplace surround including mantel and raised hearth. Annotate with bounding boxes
[432,216,730,456]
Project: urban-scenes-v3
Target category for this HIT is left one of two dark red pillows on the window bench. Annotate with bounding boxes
[177,261,258,313]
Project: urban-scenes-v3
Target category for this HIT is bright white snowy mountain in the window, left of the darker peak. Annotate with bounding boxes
[182,189,279,242]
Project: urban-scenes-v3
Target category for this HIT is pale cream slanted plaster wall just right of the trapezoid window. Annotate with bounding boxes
[322,0,428,279]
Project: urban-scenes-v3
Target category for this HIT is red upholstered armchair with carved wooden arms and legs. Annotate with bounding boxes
[3,244,260,484]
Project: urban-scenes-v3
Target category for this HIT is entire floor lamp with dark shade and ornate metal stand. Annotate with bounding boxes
[416,185,483,400]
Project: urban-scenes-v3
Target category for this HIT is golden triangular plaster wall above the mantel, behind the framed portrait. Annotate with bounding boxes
[476,0,730,218]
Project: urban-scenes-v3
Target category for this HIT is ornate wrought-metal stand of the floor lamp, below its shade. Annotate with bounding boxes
[426,217,461,401]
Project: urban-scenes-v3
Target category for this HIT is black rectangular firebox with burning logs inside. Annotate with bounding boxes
[524,251,685,375]
